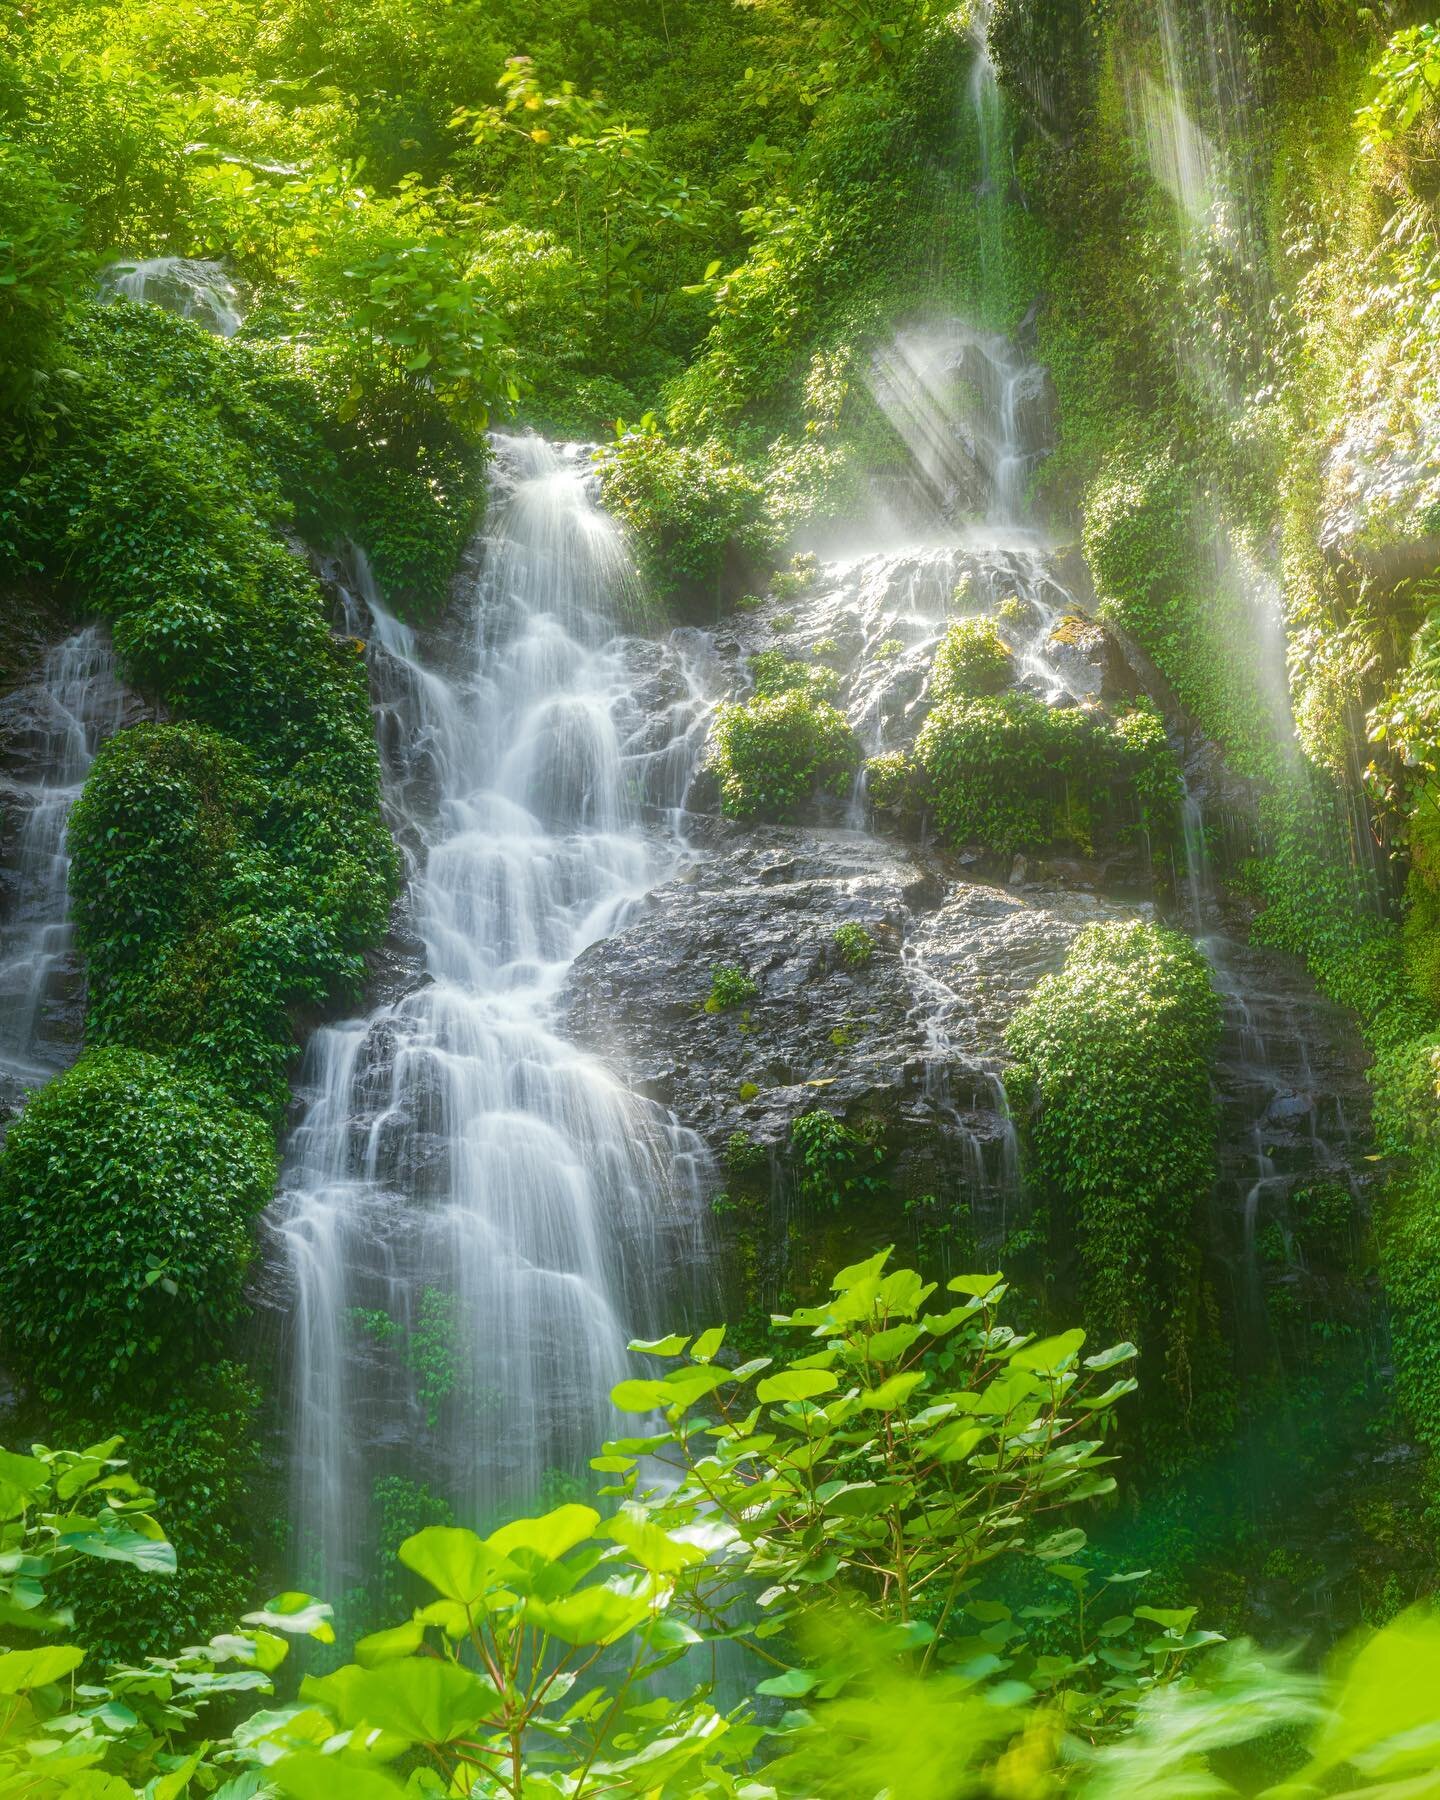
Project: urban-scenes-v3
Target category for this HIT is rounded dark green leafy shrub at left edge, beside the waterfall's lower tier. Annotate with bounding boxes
[0,1049,277,1404]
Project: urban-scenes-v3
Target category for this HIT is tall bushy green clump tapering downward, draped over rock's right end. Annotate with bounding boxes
[1006,923,1220,1343]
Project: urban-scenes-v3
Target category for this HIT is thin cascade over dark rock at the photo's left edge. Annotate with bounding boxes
[0,625,126,1105]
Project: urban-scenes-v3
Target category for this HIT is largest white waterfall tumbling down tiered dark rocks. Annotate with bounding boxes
[275,437,707,1593]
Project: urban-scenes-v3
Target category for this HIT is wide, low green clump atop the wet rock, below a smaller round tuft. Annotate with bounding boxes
[918,693,1181,855]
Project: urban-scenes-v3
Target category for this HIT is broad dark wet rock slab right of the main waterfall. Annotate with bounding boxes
[562,821,1127,1154]
